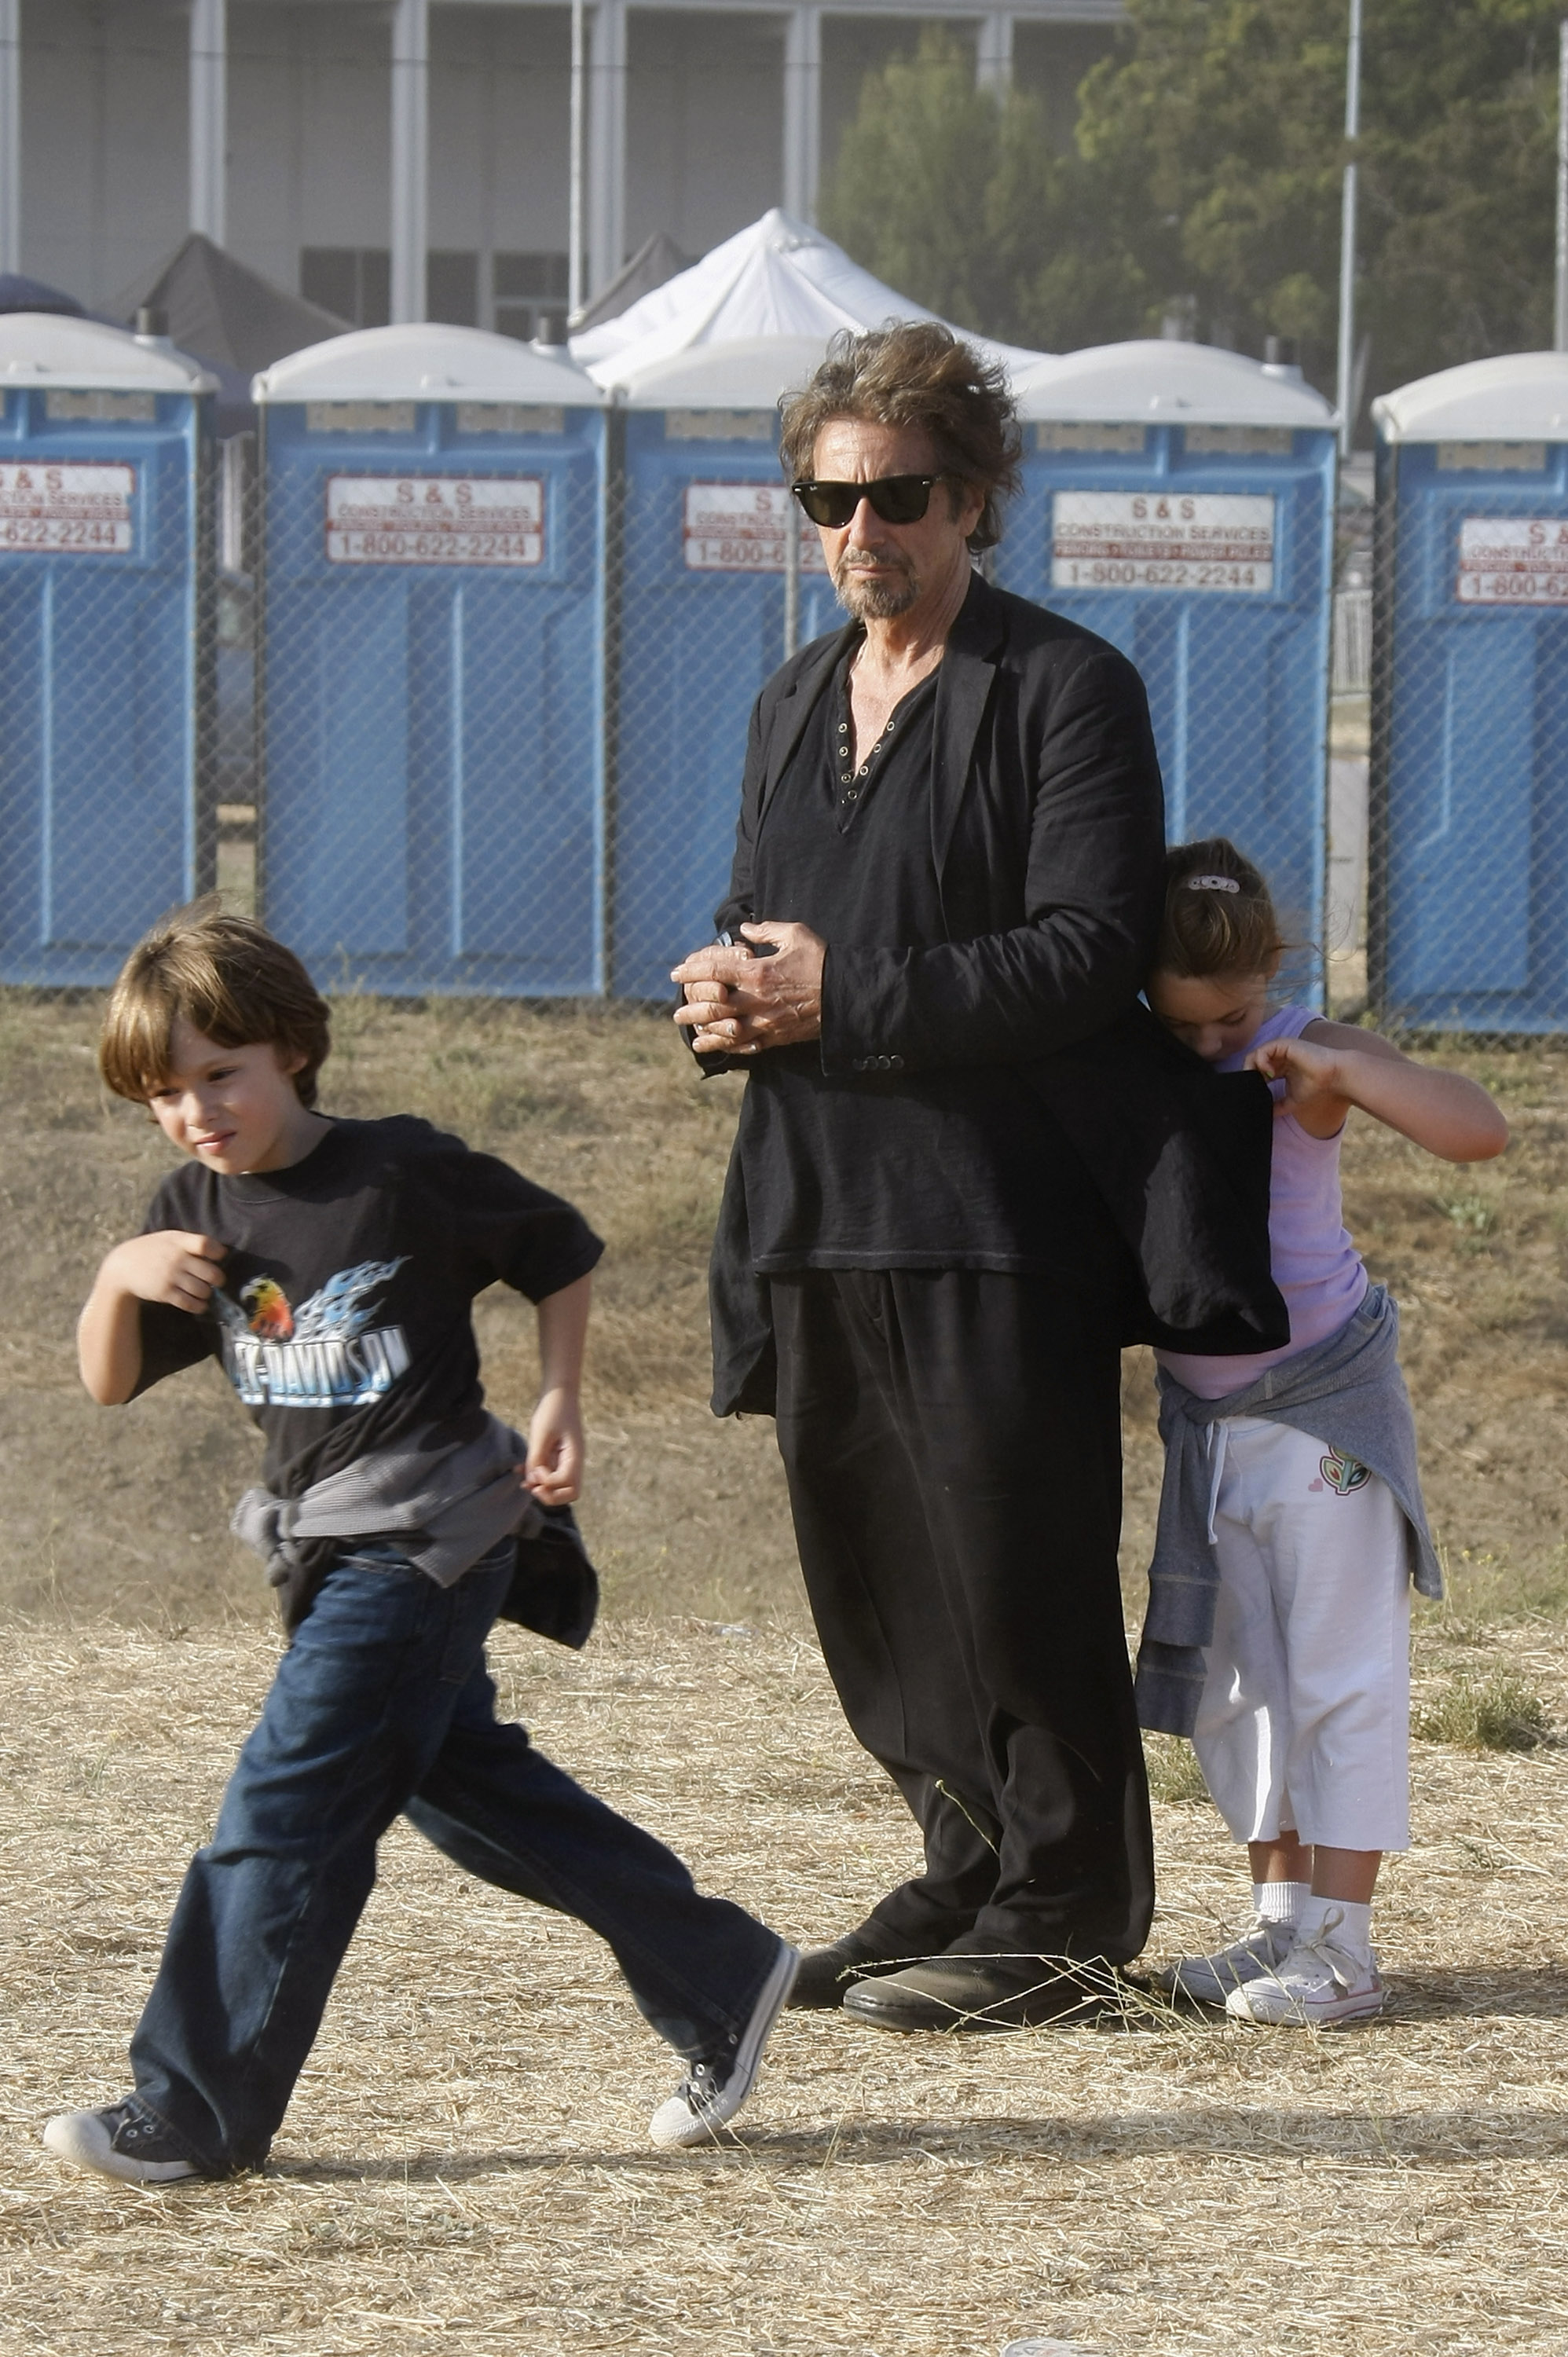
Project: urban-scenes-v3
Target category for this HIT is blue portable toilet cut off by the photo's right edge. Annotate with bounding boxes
[1368,351,1568,1032]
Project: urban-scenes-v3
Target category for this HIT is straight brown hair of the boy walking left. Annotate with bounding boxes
[99,896,332,1105]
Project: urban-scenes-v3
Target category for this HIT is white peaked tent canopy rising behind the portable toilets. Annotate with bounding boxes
[570,207,1042,389]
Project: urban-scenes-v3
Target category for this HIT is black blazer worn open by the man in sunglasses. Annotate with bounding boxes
[700,575,1290,1414]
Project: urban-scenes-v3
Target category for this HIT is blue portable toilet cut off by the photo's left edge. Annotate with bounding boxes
[0,311,217,985]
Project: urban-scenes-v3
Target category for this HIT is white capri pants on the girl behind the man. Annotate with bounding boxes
[1193,1417,1410,1850]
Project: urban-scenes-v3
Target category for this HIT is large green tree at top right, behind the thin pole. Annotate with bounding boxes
[1078,0,1559,384]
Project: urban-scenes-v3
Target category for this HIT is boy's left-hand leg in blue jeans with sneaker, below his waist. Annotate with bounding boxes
[47,1546,511,2176]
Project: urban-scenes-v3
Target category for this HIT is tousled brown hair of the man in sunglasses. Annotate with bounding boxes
[778,318,1024,552]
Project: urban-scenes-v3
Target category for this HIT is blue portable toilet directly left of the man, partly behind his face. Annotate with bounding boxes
[610,335,844,999]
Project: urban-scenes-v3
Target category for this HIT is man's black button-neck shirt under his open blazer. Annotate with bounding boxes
[738,655,1111,1275]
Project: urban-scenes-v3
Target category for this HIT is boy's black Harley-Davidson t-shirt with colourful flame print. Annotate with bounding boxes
[137,1115,603,1497]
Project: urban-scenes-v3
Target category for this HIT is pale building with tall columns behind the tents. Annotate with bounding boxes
[0,0,1120,335]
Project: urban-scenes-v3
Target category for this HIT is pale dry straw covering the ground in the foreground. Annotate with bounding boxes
[0,1622,1568,2357]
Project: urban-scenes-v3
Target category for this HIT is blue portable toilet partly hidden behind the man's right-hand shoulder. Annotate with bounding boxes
[995,339,1337,990]
